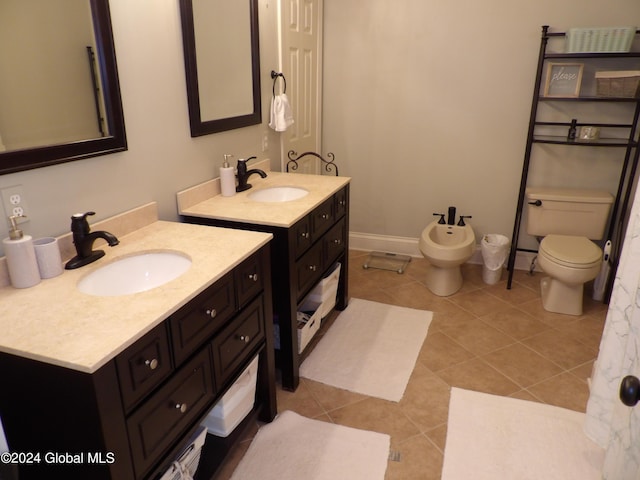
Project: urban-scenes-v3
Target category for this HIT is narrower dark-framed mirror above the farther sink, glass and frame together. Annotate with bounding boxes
[180,0,262,137]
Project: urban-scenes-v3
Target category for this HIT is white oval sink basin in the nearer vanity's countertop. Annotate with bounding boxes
[78,252,191,297]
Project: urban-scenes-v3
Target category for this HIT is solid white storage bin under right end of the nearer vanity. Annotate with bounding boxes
[202,356,258,437]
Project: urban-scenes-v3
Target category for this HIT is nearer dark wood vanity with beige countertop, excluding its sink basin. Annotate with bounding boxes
[0,215,276,480]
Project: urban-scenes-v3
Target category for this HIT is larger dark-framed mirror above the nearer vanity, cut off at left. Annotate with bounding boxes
[0,0,127,174]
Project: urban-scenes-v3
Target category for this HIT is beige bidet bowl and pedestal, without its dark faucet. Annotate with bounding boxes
[419,221,475,297]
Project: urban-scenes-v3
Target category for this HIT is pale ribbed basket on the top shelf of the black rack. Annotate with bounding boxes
[565,27,636,53]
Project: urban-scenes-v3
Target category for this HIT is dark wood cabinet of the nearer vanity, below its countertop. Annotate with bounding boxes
[0,245,276,480]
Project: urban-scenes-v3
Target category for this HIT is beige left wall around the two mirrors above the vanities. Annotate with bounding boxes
[0,0,280,255]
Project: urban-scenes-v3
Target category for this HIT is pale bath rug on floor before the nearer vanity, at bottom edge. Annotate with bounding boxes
[231,410,391,480]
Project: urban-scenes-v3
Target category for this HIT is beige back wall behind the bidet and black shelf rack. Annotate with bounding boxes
[323,0,640,251]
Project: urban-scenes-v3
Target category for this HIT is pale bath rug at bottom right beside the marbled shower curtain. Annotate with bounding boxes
[442,388,604,480]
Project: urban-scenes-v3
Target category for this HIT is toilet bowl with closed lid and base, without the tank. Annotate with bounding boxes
[538,235,602,315]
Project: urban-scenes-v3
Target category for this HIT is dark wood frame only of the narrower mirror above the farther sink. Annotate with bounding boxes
[180,0,262,137]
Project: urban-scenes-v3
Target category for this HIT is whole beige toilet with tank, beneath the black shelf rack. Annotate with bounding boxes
[526,188,613,315]
